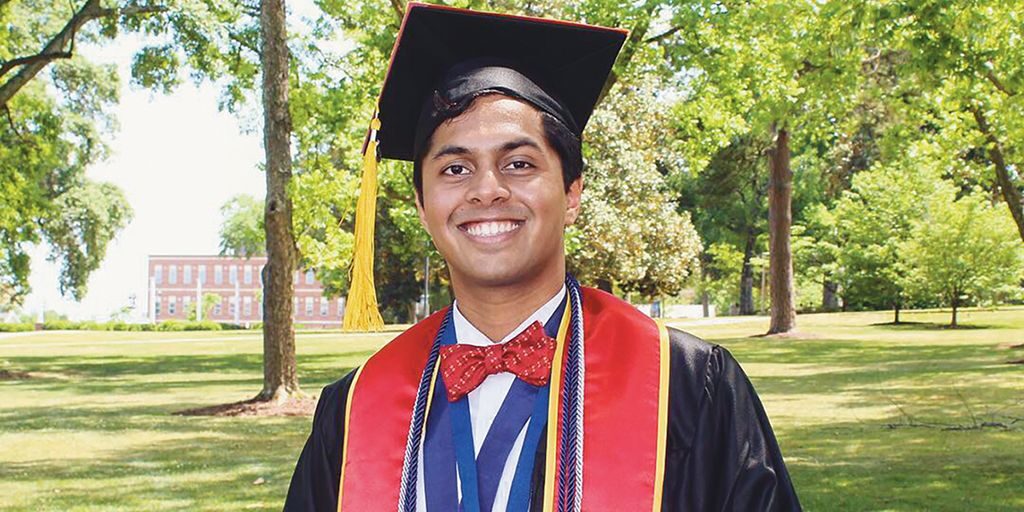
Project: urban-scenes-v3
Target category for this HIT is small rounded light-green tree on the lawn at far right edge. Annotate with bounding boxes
[902,182,1024,327]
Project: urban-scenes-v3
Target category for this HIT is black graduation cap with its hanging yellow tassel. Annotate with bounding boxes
[344,2,629,331]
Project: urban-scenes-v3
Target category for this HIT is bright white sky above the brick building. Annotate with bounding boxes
[22,2,323,321]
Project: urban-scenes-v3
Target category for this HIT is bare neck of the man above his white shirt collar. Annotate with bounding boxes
[452,263,565,342]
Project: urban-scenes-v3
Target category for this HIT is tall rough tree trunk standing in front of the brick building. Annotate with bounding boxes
[257,0,301,400]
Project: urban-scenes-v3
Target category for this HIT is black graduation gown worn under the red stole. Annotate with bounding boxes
[285,329,800,512]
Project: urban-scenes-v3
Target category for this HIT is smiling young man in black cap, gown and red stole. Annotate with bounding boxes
[285,4,800,512]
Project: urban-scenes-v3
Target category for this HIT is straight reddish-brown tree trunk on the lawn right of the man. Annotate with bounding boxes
[768,128,797,334]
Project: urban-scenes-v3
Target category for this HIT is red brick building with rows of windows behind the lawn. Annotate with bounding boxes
[147,255,345,328]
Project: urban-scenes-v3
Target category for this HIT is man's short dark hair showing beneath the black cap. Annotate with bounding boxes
[413,91,583,199]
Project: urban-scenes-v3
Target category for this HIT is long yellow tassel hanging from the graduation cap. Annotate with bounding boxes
[344,114,384,331]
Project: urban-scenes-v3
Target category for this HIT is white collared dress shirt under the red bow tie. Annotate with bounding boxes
[416,285,565,512]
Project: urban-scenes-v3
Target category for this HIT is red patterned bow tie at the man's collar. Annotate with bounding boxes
[441,322,555,401]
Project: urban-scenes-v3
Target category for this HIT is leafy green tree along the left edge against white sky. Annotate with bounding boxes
[0,1,145,304]
